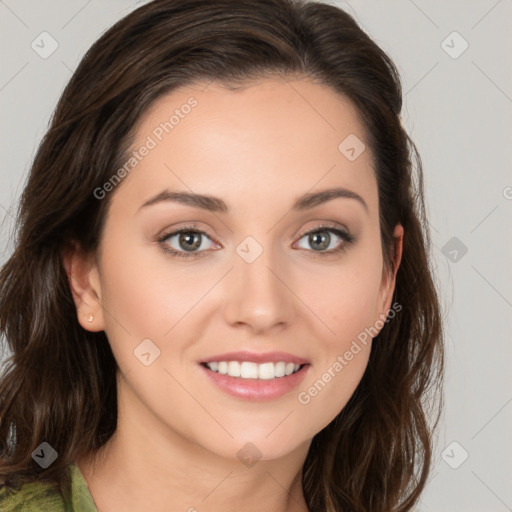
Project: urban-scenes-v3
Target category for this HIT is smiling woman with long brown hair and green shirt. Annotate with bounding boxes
[0,0,443,512]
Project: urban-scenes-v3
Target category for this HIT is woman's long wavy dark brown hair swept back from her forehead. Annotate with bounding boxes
[0,0,443,512]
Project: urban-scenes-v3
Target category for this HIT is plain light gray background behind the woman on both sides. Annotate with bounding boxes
[0,0,512,512]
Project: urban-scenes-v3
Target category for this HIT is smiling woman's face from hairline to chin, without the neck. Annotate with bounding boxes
[73,79,401,459]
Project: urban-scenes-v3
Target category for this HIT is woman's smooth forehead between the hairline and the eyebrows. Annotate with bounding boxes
[110,79,376,217]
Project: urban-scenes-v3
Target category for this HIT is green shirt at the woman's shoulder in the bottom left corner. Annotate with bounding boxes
[0,464,98,512]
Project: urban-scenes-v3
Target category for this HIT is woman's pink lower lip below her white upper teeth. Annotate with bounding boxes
[200,364,310,401]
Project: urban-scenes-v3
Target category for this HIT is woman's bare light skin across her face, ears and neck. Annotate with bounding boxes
[64,77,403,512]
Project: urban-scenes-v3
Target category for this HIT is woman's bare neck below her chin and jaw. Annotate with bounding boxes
[77,376,310,512]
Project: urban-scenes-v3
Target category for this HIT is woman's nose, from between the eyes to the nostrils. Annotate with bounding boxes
[224,244,297,334]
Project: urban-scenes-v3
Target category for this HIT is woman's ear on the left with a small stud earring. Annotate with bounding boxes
[62,242,104,331]
